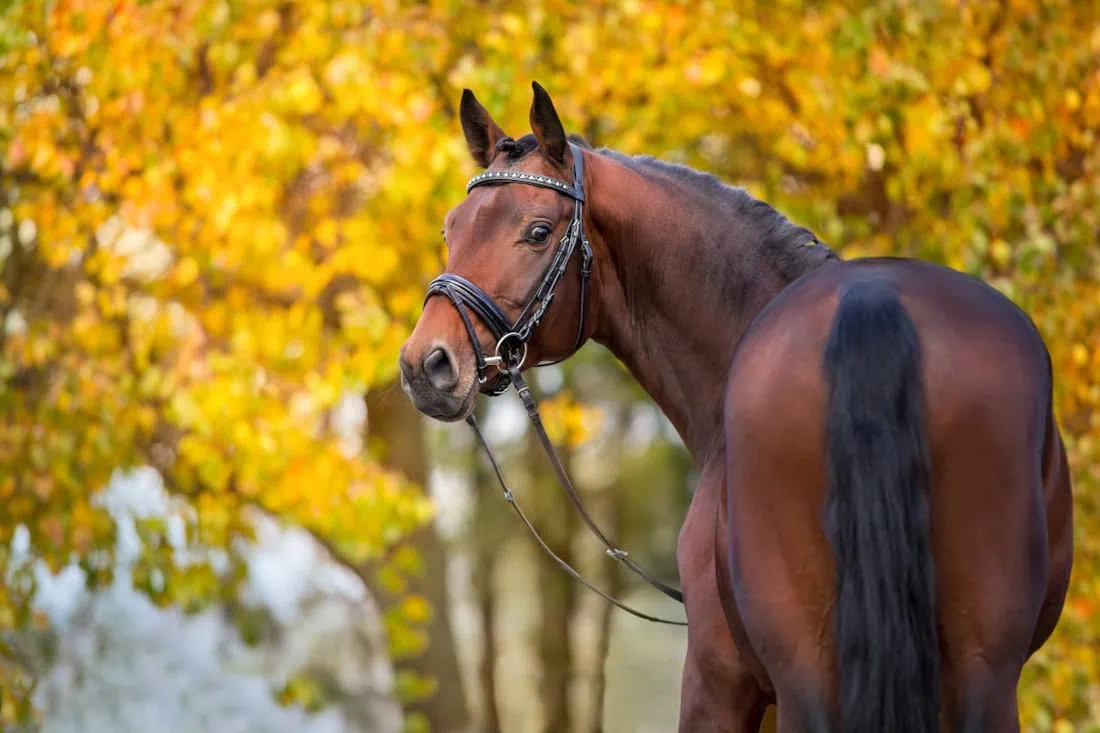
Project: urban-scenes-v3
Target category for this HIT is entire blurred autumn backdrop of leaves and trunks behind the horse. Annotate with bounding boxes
[0,0,1100,733]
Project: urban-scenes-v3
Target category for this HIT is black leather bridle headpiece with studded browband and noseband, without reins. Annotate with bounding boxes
[425,144,592,395]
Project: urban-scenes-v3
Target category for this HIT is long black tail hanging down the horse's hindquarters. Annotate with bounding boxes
[825,281,939,733]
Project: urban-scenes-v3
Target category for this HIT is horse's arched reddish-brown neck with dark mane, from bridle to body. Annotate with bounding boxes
[585,153,827,466]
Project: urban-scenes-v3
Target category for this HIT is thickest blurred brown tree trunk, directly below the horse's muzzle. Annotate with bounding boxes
[366,387,470,733]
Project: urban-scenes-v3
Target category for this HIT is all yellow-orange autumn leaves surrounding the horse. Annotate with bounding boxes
[0,0,1100,730]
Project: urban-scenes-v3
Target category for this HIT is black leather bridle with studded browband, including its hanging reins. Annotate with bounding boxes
[425,144,688,626]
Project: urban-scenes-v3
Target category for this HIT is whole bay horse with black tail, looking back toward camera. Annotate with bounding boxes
[400,84,1073,733]
